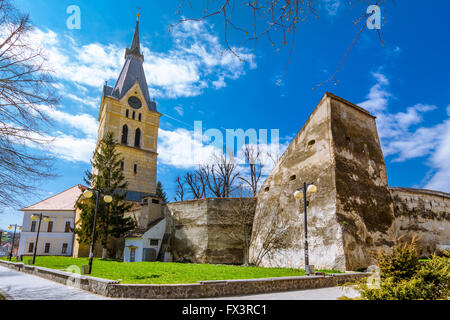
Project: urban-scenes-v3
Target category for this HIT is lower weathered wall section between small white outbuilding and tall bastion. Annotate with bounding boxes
[166,198,254,264]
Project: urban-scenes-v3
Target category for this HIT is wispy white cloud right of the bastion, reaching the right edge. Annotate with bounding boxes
[359,73,450,192]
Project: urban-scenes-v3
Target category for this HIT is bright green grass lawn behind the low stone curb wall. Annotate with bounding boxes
[2,256,339,284]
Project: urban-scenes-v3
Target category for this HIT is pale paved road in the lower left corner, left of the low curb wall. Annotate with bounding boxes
[0,266,108,300]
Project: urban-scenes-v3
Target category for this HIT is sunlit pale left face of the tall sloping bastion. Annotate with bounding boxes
[250,96,346,270]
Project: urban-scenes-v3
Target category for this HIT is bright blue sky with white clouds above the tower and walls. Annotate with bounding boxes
[0,0,450,228]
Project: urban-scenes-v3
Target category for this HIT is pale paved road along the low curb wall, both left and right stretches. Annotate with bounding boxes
[0,266,358,300]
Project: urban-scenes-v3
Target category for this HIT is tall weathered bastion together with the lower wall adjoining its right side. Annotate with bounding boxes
[250,93,450,270]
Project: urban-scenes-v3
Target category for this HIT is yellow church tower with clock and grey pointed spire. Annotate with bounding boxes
[97,14,161,201]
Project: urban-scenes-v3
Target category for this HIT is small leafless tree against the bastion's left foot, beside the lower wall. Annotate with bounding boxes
[250,206,292,266]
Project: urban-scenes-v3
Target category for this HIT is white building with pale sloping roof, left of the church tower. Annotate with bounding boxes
[18,185,84,256]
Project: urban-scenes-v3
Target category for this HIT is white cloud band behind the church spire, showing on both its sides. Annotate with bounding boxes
[30,21,256,98]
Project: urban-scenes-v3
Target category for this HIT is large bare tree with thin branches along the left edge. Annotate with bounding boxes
[0,0,58,206]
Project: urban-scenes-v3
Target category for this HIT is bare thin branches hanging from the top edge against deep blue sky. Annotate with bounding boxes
[171,0,386,86]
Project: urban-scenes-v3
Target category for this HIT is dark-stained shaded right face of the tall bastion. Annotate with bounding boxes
[329,95,394,270]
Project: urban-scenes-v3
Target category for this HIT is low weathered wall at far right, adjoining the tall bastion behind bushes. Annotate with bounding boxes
[390,188,450,256]
